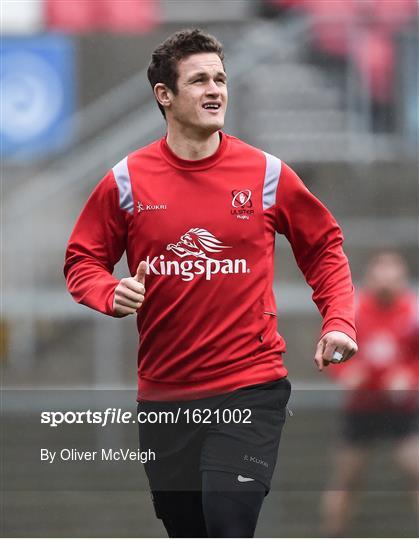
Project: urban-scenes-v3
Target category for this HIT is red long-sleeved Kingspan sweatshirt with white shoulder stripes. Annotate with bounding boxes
[64,134,355,400]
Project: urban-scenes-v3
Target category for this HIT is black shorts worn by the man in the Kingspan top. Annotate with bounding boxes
[138,378,291,491]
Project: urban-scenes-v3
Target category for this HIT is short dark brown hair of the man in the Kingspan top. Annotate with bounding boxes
[147,28,224,118]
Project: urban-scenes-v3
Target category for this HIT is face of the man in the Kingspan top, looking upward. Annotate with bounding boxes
[166,53,228,135]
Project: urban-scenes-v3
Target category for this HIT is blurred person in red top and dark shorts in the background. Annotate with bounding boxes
[323,251,419,536]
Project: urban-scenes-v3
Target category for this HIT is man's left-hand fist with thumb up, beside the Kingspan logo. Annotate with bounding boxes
[113,261,147,317]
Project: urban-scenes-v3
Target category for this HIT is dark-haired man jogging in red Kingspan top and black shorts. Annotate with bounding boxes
[64,30,357,537]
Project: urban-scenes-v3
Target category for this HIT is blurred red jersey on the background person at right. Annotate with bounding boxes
[329,292,419,411]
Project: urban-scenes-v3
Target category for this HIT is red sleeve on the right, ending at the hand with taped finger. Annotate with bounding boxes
[276,164,356,340]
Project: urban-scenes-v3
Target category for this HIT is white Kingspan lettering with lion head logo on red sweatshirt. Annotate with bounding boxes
[146,228,250,281]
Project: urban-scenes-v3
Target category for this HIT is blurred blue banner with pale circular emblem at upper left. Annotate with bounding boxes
[0,35,75,160]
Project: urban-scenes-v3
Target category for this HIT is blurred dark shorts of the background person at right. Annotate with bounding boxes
[343,410,419,444]
